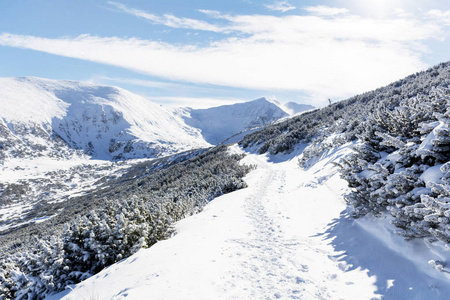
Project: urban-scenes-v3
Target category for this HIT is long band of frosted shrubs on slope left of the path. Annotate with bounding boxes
[0,146,252,299]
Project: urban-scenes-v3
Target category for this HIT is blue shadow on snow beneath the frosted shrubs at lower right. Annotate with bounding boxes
[316,211,450,300]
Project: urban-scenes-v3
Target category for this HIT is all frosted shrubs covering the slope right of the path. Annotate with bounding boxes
[239,63,450,248]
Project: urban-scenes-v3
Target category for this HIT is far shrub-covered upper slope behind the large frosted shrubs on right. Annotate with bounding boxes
[239,62,450,154]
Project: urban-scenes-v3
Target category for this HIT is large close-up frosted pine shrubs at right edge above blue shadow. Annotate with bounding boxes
[341,89,450,244]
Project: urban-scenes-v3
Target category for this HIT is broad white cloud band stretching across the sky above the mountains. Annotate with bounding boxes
[0,6,441,101]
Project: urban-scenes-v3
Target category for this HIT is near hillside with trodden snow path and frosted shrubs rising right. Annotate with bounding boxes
[46,63,450,299]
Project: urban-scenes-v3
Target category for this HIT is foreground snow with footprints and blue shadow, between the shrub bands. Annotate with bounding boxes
[48,145,450,299]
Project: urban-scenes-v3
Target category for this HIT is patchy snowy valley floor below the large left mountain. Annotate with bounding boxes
[0,156,133,233]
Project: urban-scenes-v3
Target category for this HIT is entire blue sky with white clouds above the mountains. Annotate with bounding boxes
[0,0,450,107]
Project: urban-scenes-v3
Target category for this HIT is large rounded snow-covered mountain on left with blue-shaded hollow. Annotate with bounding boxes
[0,77,209,160]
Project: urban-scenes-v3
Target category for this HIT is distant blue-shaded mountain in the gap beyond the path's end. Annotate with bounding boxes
[179,98,288,145]
